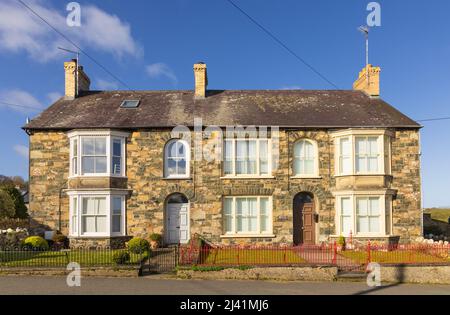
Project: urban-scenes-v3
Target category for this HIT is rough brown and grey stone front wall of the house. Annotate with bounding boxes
[30,129,421,246]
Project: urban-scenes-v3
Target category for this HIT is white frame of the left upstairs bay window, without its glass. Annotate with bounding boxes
[67,130,130,178]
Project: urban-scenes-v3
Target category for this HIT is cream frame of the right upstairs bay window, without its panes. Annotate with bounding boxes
[331,129,393,177]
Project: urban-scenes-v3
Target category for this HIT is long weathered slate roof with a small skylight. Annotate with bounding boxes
[23,90,421,130]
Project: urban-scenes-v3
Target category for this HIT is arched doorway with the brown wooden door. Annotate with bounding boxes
[293,192,316,245]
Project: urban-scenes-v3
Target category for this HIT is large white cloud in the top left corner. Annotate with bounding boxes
[0,0,143,62]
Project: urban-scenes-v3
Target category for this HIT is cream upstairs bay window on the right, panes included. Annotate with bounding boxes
[332,130,392,176]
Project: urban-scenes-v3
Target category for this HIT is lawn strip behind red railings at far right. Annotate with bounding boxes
[339,250,450,264]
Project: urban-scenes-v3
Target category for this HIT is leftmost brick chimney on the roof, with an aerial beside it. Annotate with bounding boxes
[64,59,91,99]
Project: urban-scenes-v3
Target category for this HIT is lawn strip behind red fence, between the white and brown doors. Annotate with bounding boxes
[201,248,306,265]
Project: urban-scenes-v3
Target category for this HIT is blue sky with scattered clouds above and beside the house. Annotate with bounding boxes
[0,0,450,207]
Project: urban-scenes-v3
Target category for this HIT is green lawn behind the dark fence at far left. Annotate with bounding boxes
[0,250,144,267]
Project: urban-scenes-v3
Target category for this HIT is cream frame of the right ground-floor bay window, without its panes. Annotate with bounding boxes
[335,191,392,237]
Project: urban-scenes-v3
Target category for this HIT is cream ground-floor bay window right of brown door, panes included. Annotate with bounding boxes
[336,192,392,237]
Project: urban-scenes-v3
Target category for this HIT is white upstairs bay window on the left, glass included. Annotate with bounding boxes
[68,131,128,177]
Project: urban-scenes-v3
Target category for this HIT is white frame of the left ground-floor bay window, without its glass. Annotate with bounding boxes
[68,191,128,238]
